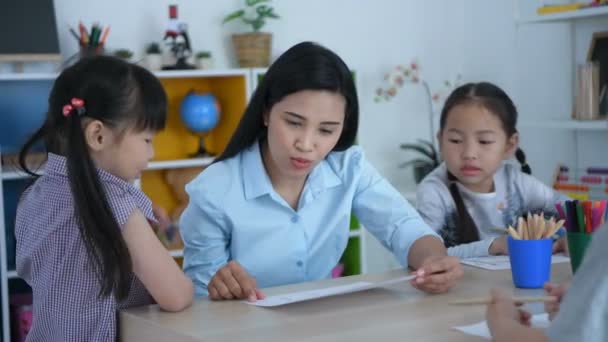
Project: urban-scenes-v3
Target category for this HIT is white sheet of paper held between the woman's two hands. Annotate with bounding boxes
[245,276,414,307]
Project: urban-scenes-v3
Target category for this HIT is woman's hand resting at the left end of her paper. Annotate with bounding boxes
[207,261,266,302]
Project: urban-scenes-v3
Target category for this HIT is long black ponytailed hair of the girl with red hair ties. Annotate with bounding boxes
[19,56,167,300]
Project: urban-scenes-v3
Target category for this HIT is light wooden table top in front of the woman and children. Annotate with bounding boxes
[120,263,571,342]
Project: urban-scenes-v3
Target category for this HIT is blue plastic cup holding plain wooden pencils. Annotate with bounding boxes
[507,236,553,289]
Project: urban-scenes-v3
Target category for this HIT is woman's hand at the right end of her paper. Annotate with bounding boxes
[410,256,463,293]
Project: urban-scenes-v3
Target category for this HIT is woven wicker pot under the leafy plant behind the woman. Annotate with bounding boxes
[232,32,272,68]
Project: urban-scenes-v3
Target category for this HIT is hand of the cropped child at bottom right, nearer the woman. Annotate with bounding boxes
[486,289,531,336]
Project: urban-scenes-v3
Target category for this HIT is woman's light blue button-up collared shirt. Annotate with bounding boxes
[180,143,437,296]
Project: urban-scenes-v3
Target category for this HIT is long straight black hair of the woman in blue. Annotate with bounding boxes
[215,42,359,162]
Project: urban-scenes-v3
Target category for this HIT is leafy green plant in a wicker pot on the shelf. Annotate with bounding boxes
[223,0,279,68]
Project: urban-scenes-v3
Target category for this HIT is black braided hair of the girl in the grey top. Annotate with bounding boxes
[439,82,532,244]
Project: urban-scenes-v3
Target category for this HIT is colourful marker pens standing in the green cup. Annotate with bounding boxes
[555,200,608,234]
